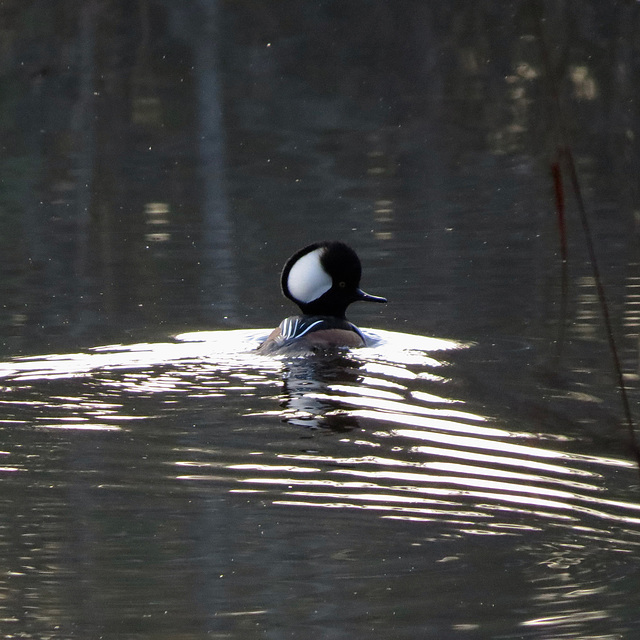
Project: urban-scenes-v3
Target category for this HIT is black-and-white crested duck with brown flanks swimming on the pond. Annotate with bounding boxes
[258,242,387,353]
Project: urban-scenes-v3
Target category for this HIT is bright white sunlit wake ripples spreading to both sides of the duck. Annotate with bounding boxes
[0,330,640,546]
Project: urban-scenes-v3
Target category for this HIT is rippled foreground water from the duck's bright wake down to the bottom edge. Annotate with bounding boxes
[0,330,640,638]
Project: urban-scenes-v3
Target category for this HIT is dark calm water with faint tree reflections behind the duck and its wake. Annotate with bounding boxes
[0,0,640,354]
